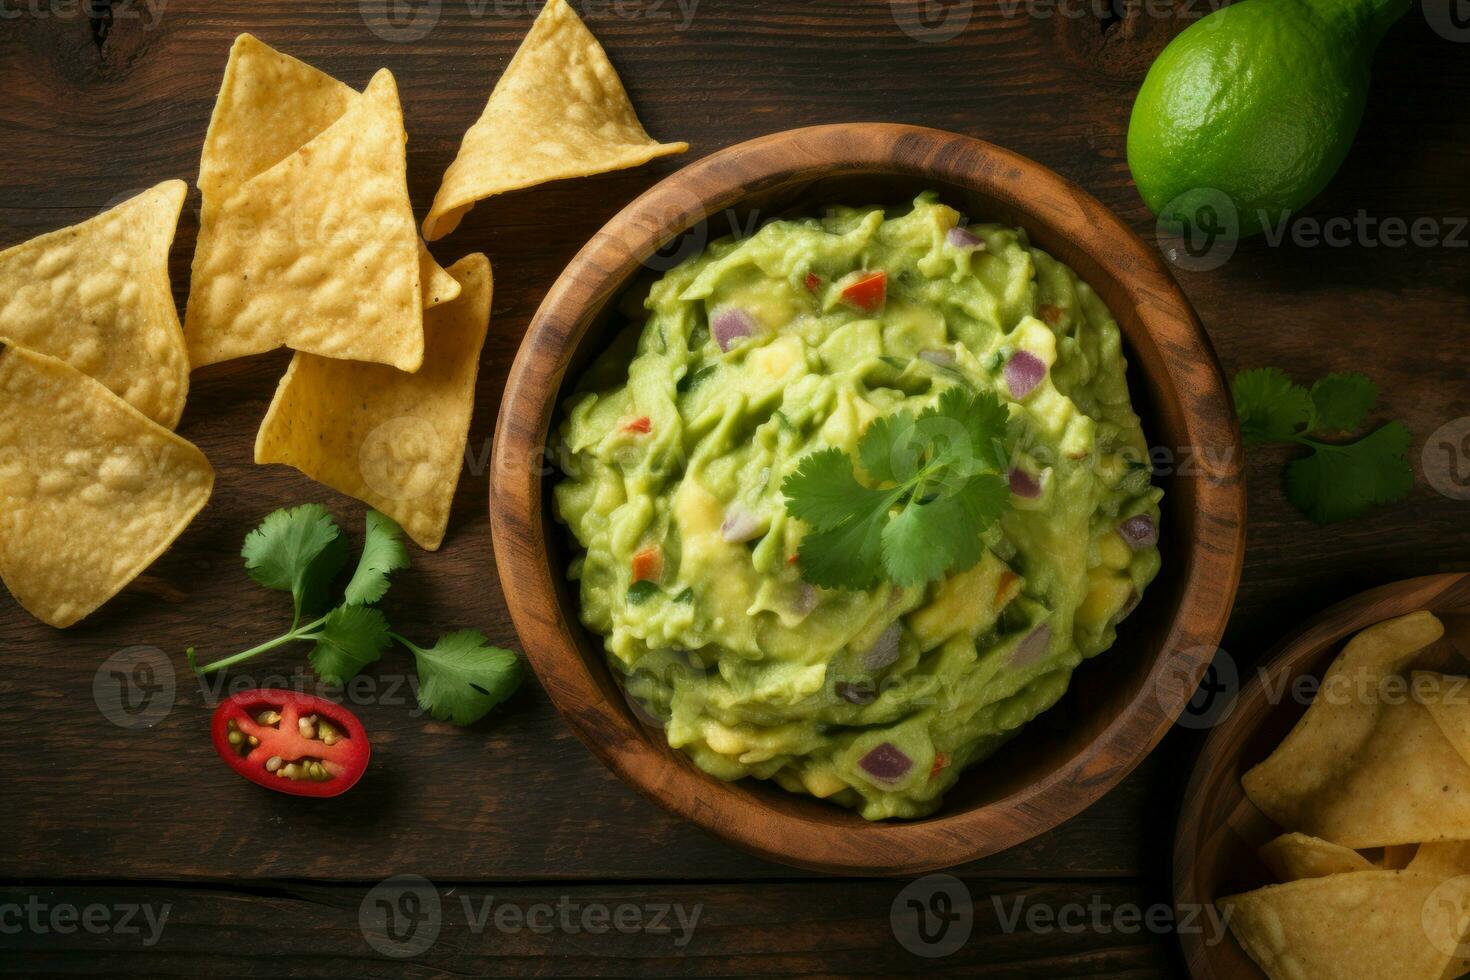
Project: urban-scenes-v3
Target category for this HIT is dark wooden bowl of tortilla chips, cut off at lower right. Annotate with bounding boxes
[1175,573,1470,980]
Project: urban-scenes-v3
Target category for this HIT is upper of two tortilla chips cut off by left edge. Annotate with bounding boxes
[0,181,188,429]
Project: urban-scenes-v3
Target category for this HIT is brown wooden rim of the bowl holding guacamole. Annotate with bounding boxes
[490,123,1245,874]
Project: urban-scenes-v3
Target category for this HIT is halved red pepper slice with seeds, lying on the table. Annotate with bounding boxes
[210,689,372,796]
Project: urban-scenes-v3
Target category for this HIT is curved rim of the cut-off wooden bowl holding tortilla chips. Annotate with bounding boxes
[1172,572,1470,980]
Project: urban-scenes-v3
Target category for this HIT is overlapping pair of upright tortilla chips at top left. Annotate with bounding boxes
[184,35,453,370]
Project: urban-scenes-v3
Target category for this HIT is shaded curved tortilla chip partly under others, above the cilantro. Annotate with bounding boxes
[256,253,492,551]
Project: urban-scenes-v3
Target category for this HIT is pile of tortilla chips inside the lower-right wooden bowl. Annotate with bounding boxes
[1219,611,1470,980]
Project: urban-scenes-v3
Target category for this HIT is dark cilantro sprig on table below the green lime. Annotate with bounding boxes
[1233,367,1414,525]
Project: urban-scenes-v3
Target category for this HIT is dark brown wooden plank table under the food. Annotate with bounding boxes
[0,0,1470,977]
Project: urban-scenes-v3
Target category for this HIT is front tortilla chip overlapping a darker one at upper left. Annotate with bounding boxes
[184,69,423,370]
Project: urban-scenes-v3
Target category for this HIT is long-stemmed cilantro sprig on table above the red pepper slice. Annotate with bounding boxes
[187,504,520,724]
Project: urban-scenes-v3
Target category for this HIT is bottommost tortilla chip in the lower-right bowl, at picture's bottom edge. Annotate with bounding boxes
[1219,871,1470,980]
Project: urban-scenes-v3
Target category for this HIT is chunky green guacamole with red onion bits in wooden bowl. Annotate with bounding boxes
[556,194,1161,820]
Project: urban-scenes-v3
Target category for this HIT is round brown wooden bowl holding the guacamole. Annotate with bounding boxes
[491,123,1245,874]
